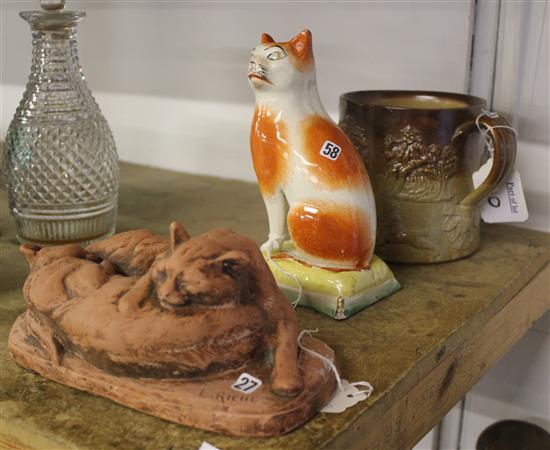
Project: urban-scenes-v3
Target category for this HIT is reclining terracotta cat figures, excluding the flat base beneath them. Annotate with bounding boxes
[17,223,303,396]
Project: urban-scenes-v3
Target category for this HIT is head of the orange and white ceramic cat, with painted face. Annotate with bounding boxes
[248,30,314,91]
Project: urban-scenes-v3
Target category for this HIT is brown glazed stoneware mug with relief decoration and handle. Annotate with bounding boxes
[340,91,516,263]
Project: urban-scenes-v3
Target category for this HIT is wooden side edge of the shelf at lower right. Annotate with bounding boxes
[331,266,550,449]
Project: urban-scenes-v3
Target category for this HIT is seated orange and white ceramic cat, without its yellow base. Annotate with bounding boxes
[248,30,376,270]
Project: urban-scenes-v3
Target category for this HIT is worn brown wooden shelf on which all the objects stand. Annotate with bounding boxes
[0,165,550,450]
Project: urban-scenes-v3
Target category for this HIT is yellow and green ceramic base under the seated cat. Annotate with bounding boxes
[264,241,401,320]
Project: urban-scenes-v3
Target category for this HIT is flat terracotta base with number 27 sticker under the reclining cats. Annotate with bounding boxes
[8,312,336,436]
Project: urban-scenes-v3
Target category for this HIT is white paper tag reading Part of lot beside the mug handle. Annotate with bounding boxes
[472,160,529,223]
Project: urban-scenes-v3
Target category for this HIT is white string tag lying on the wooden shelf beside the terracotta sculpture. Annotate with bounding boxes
[297,330,374,413]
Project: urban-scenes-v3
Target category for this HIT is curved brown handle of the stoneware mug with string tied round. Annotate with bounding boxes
[460,114,517,207]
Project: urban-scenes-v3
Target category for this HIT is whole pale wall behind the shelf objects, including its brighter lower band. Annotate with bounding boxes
[0,1,473,180]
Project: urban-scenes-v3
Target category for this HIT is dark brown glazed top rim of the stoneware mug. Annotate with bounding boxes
[340,90,486,111]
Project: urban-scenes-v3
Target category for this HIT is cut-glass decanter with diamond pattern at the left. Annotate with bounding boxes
[4,0,118,245]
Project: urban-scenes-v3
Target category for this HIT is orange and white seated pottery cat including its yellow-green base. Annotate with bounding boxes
[248,30,399,319]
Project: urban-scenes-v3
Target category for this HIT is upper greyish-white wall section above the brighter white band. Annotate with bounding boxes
[2,1,471,110]
